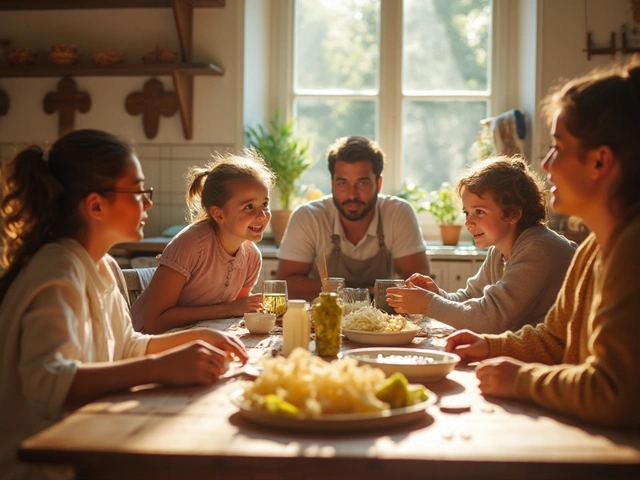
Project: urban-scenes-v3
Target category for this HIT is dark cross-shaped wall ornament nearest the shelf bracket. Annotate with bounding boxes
[124,78,178,138]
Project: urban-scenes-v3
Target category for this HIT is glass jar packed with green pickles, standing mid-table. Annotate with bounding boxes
[313,292,344,356]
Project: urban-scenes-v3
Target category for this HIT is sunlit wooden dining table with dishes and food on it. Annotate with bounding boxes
[19,318,640,480]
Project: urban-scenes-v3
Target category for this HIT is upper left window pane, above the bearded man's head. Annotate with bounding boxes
[294,0,380,91]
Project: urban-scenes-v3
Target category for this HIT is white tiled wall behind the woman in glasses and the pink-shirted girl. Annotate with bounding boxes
[0,143,234,237]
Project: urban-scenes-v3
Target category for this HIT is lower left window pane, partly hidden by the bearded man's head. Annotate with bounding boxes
[295,98,377,194]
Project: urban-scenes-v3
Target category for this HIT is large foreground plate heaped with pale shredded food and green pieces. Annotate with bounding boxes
[231,348,437,431]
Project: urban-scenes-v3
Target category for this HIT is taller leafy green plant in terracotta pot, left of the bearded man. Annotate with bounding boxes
[245,110,315,246]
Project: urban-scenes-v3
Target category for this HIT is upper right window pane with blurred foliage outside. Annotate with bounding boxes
[402,0,491,93]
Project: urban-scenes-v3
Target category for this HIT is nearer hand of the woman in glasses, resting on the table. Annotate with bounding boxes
[154,340,228,386]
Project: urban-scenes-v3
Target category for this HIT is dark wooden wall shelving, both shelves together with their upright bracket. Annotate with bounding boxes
[0,0,225,140]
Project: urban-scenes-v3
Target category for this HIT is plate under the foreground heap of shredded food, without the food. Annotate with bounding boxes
[231,388,438,432]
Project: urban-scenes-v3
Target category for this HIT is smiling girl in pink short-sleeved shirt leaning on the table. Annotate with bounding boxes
[131,151,274,333]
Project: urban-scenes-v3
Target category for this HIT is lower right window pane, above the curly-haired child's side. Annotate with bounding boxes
[402,101,488,191]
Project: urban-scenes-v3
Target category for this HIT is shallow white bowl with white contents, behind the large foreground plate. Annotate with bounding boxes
[341,348,460,382]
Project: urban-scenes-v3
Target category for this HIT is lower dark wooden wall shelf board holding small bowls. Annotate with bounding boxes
[0,63,224,78]
